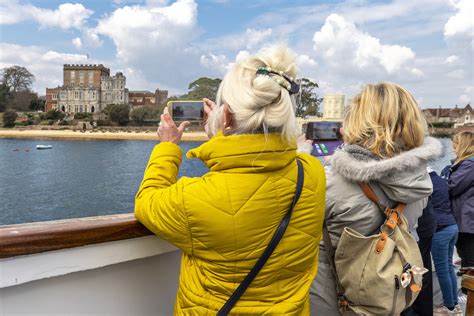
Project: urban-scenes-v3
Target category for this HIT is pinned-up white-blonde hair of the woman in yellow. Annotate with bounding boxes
[208,46,299,144]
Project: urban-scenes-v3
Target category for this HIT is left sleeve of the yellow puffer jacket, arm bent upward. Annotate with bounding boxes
[135,143,192,253]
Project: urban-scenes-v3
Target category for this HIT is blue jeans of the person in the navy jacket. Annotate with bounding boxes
[431,224,458,308]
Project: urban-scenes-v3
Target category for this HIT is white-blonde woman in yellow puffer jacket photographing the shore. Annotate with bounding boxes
[135,47,325,316]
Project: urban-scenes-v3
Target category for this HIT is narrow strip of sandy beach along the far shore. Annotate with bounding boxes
[0,129,208,141]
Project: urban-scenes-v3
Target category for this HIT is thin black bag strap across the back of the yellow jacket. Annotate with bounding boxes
[217,159,304,316]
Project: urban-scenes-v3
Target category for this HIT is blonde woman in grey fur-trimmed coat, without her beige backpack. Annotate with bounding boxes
[302,82,441,316]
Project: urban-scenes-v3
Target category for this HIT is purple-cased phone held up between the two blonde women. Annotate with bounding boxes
[305,122,343,157]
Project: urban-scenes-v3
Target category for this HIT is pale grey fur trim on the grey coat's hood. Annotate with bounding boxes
[331,137,442,182]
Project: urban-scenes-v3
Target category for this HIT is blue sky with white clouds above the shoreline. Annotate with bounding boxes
[0,0,474,107]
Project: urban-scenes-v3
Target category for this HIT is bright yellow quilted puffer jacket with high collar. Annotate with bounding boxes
[135,134,326,315]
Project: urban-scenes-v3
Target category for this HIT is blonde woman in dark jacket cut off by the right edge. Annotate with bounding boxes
[448,131,474,271]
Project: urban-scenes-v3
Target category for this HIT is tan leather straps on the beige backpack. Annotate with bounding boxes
[359,183,407,254]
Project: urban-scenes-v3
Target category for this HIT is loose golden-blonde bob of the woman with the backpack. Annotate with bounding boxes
[343,82,427,158]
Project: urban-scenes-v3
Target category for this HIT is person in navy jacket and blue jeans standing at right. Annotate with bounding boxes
[428,168,462,316]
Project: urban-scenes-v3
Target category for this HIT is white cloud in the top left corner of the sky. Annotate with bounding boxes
[0,0,94,29]
